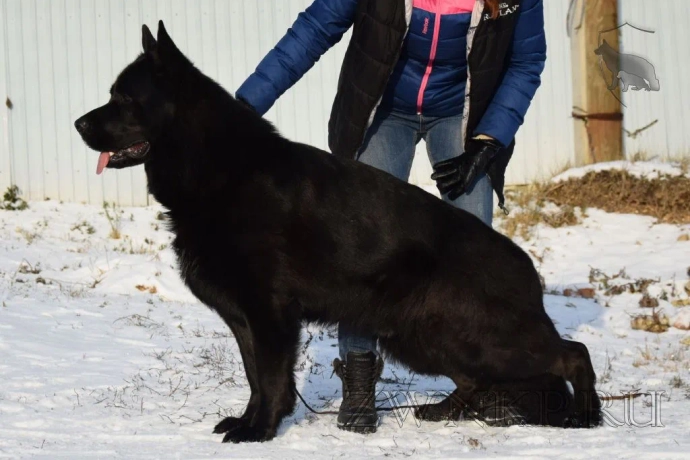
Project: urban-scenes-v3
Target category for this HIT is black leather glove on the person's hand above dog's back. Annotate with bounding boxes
[431,139,503,200]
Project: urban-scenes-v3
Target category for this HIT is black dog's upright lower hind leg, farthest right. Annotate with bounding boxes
[551,340,601,428]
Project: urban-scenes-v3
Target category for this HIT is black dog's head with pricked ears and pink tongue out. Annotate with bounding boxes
[74,21,188,174]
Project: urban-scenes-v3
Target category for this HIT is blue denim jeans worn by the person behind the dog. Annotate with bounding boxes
[338,112,493,360]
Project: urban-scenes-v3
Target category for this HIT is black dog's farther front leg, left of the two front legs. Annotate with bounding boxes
[213,309,260,433]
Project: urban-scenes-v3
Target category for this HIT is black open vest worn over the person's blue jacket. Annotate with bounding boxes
[328,0,520,206]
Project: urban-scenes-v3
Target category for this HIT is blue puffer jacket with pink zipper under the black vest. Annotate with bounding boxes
[236,0,546,145]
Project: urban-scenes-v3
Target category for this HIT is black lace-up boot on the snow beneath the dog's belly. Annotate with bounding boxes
[333,351,383,433]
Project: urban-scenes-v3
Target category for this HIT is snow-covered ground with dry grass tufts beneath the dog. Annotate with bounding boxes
[0,162,690,459]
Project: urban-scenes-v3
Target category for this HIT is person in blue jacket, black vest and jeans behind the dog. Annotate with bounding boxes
[236,0,546,433]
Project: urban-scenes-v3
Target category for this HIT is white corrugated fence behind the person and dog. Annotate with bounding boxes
[0,0,690,205]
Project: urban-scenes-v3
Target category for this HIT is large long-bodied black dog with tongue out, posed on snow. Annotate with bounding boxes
[75,22,600,442]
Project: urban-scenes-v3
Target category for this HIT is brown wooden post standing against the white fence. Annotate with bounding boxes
[570,0,623,166]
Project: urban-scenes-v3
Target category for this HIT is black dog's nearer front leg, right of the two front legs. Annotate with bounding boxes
[223,318,300,443]
